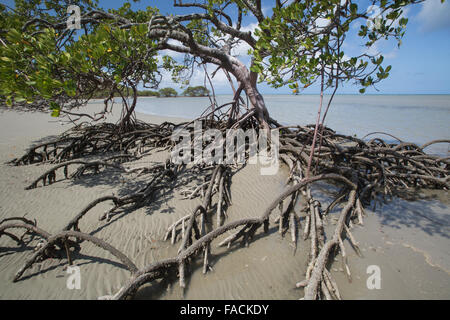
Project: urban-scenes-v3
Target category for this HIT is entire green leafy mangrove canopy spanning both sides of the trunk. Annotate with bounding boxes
[0,0,428,116]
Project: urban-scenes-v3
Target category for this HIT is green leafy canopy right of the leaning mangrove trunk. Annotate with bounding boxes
[251,0,420,93]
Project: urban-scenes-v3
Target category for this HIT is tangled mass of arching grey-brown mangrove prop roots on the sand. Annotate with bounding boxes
[0,116,450,299]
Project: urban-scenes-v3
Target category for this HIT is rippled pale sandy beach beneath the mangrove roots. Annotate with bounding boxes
[0,103,450,299]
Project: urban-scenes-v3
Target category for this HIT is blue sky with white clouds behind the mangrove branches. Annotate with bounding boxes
[0,0,450,94]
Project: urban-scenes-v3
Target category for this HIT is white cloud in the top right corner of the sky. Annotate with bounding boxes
[416,0,450,32]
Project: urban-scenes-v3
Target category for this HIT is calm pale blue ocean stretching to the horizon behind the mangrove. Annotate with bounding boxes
[136,95,450,155]
